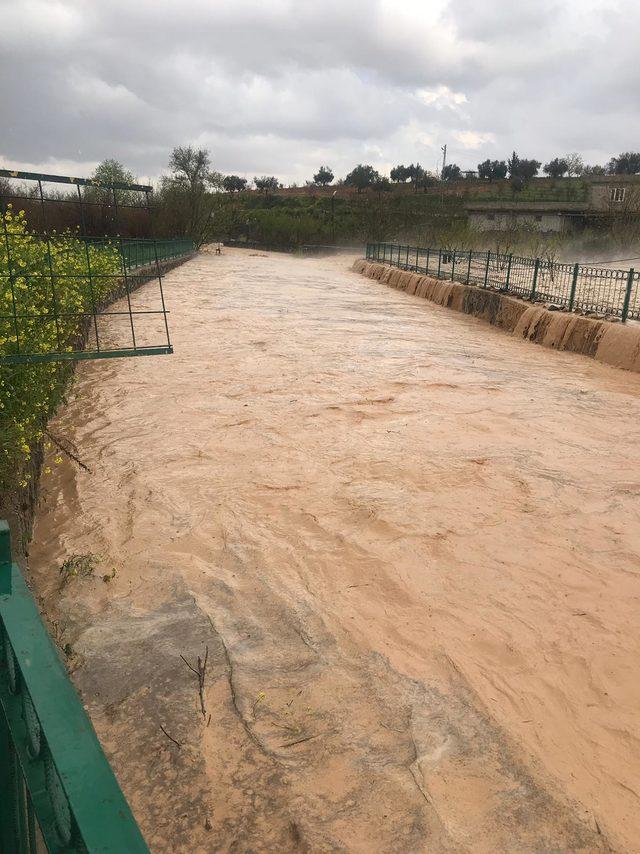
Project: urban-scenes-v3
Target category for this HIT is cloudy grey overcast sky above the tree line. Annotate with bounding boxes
[0,0,640,182]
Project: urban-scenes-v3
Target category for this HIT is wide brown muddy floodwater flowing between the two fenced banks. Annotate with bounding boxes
[31,250,640,854]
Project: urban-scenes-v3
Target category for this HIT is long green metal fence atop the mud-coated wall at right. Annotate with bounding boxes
[366,243,640,323]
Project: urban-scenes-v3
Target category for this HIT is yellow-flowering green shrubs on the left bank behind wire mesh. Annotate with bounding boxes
[0,207,121,499]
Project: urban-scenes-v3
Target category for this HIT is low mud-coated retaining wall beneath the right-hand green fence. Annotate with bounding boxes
[353,259,640,371]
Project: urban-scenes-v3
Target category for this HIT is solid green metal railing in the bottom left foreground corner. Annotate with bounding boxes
[0,521,148,854]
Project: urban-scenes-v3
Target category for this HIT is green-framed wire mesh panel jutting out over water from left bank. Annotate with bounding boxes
[0,170,193,364]
